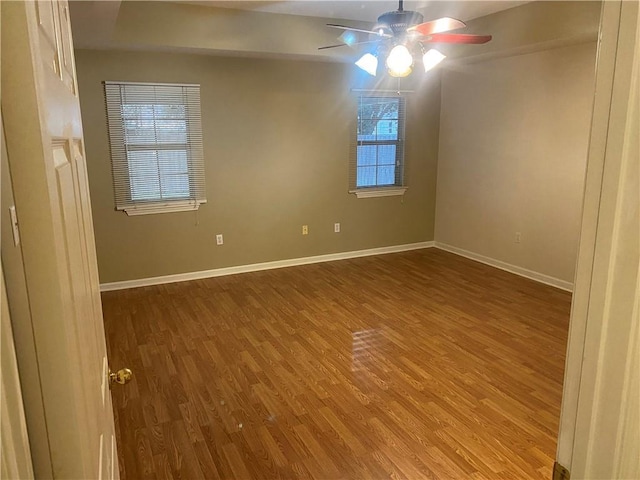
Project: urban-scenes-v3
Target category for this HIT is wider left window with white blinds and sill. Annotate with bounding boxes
[105,82,206,215]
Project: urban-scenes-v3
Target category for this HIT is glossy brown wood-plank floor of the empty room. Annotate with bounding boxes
[103,249,570,480]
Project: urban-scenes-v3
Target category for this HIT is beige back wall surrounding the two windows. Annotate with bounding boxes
[76,50,440,283]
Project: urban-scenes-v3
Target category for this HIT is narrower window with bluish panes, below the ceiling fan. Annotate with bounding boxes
[350,96,406,198]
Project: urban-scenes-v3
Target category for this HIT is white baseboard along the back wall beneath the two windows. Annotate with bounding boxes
[100,242,434,292]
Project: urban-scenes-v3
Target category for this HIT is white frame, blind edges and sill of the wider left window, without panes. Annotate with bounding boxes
[103,81,207,216]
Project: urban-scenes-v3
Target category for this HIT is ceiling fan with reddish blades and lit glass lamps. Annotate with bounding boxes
[318,0,491,77]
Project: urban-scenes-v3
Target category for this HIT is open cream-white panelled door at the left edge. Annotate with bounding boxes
[1,0,119,479]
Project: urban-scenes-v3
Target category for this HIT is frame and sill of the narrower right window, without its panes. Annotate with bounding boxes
[349,91,408,198]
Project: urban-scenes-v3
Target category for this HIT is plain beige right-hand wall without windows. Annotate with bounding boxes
[435,42,595,282]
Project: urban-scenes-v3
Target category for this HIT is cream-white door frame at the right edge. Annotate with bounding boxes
[556,0,640,478]
